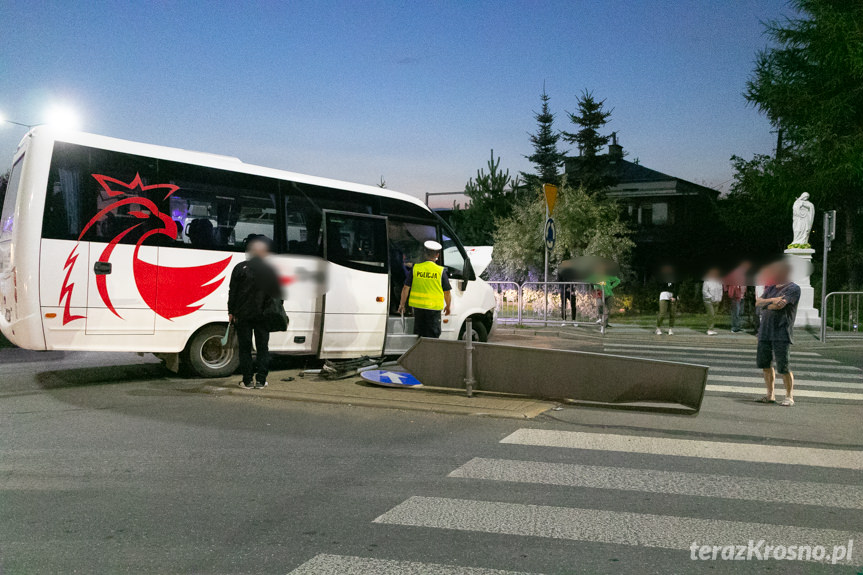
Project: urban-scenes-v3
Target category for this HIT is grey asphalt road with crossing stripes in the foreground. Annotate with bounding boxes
[0,342,863,575]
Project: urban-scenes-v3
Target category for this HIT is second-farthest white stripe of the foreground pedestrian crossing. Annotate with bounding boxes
[449,457,863,509]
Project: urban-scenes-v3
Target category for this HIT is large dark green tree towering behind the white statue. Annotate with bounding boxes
[741,0,863,285]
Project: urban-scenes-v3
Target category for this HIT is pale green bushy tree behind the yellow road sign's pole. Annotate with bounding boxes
[494,182,634,281]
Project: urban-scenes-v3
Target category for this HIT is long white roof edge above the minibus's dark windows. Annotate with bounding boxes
[18,126,431,211]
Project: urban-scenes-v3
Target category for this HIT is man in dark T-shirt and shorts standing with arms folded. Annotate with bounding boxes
[755,260,800,407]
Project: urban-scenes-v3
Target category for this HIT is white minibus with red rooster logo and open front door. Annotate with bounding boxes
[0,127,495,377]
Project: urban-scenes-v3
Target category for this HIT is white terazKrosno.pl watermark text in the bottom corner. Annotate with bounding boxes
[689,539,854,565]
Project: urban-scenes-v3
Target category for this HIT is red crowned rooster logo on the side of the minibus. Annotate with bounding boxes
[59,174,231,325]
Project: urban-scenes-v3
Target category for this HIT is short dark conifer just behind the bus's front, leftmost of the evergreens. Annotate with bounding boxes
[450,150,521,245]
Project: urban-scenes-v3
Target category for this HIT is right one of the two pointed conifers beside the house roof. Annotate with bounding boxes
[561,90,614,194]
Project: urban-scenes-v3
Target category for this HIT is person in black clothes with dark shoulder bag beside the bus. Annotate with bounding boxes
[228,236,281,389]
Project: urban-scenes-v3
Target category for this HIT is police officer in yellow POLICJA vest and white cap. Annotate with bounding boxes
[399,240,452,338]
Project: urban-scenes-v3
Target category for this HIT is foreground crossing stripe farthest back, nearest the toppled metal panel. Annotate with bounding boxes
[500,430,863,470]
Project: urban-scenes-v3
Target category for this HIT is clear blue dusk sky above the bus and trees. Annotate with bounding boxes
[0,0,789,203]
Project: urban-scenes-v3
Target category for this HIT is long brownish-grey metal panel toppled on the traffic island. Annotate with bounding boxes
[399,338,708,414]
